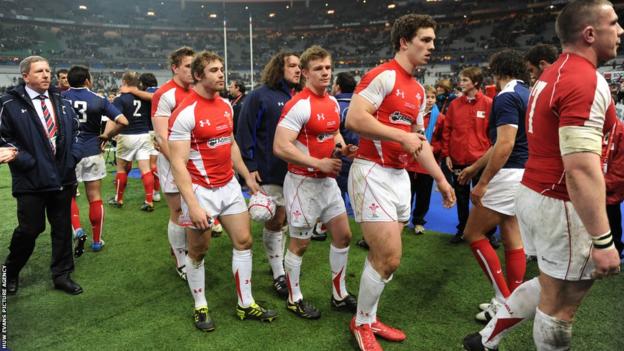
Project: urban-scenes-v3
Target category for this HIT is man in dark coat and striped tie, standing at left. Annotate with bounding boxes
[0,56,82,295]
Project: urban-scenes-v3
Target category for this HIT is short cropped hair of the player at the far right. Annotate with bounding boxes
[555,0,613,45]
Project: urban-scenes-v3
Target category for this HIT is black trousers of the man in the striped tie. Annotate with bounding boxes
[5,186,75,279]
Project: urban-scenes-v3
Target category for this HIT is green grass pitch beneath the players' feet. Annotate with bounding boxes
[0,165,624,351]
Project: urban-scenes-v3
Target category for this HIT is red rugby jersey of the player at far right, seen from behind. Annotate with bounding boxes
[522,53,617,201]
